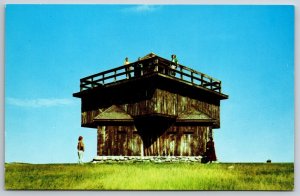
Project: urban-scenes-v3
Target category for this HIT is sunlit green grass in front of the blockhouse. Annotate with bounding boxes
[5,163,294,190]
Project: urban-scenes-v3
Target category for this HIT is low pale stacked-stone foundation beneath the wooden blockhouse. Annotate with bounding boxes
[92,156,202,163]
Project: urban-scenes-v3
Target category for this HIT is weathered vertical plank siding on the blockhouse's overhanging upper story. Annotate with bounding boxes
[81,89,220,126]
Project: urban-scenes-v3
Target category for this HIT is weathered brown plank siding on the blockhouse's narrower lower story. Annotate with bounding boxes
[97,126,211,156]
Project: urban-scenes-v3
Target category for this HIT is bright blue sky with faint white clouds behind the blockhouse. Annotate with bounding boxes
[5,5,294,163]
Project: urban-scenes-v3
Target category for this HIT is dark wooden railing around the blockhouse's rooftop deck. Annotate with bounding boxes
[80,56,221,93]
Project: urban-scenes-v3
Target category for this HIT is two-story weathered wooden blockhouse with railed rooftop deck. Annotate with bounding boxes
[73,53,228,156]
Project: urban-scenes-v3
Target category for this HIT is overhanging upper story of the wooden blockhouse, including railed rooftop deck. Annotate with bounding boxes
[73,53,228,128]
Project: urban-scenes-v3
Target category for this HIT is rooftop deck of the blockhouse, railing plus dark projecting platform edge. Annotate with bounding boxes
[73,53,228,99]
